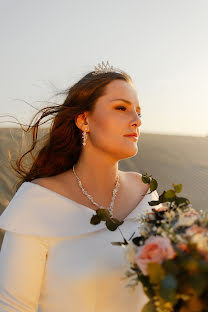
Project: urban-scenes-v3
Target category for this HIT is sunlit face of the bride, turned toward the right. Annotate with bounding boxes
[84,79,141,161]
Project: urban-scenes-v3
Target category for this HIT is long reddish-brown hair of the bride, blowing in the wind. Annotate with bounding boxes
[10,71,133,189]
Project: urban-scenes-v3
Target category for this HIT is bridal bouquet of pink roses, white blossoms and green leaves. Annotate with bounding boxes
[91,174,208,312]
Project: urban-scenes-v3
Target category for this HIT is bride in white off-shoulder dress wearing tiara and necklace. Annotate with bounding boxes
[0,64,158,312]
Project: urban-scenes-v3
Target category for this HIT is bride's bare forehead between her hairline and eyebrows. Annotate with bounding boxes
[104,79,139,103]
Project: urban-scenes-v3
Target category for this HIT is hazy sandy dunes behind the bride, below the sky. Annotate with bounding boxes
[0,128,208,244]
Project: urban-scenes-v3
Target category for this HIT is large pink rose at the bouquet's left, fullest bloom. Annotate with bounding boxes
[135,236,176,275]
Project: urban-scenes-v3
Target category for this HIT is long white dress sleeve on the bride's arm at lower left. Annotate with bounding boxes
[0,231,48,312]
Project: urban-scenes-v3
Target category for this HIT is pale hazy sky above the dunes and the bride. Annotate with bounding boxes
[0,0,208,135]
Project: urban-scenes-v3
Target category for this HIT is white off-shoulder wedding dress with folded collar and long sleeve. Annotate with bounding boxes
[0,182,161,312]
